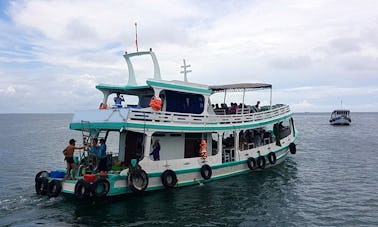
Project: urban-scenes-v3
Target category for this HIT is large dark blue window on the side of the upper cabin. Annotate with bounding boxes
[165,91,205,114]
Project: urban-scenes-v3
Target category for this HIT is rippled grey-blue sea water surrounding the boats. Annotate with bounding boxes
[0,113,378,226]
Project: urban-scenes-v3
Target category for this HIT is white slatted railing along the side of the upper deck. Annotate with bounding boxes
[127,105,290,125]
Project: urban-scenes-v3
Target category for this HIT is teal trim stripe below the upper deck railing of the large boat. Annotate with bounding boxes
[70,113,292,131]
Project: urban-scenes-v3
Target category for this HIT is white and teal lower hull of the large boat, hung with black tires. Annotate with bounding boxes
[36,143,295,198]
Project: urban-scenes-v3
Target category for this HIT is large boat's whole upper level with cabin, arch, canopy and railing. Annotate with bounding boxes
[70,50,291,130]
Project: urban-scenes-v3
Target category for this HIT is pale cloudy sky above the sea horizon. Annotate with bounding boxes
[0,0,378,113]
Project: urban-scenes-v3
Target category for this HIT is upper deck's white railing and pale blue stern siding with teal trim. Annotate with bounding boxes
[70,104,291,130]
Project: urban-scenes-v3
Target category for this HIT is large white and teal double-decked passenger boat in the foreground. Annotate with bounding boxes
[35,49,297,198]
